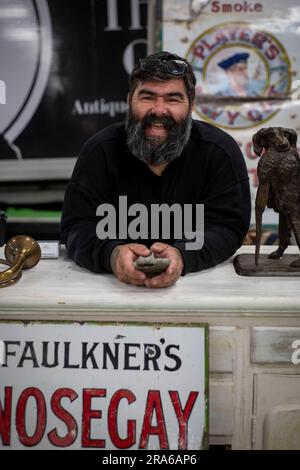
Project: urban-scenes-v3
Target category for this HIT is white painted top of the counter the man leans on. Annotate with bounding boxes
[0,247,300,320]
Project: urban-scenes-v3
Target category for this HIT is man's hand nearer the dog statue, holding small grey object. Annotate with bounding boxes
[144,242,184,287]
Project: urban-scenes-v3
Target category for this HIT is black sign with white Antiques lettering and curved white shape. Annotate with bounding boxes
[0,0,147,160]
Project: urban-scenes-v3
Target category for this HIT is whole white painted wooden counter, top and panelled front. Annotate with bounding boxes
[0,247,300,449]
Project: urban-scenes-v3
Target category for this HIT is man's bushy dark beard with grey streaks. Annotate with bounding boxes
[125,109,192,165]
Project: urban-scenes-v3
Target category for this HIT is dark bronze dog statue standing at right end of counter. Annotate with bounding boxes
[252,127,300,268]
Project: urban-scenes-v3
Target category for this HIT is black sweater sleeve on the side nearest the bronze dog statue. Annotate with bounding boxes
[174,139,251,274]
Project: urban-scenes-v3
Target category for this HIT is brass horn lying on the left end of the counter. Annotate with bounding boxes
[0,235,41,287]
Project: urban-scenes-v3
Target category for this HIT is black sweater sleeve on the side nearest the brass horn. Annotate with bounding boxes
[61,145,124,273]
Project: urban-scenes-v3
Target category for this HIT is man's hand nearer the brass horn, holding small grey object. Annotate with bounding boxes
[110,243,151,286]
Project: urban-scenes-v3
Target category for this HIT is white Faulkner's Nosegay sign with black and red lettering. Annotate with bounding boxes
[0,323,207,449]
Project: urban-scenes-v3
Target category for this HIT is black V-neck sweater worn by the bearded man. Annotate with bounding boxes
[61,121,251,274]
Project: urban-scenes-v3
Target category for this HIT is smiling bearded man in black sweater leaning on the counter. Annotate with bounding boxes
[61,52,251,288]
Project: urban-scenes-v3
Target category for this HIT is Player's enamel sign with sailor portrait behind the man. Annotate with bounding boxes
[162,0,300,223]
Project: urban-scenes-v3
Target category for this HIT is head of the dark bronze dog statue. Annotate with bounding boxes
[252,127,297,157]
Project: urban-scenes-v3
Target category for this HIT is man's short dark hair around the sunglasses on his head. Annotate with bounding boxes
[129,51,196,104]
